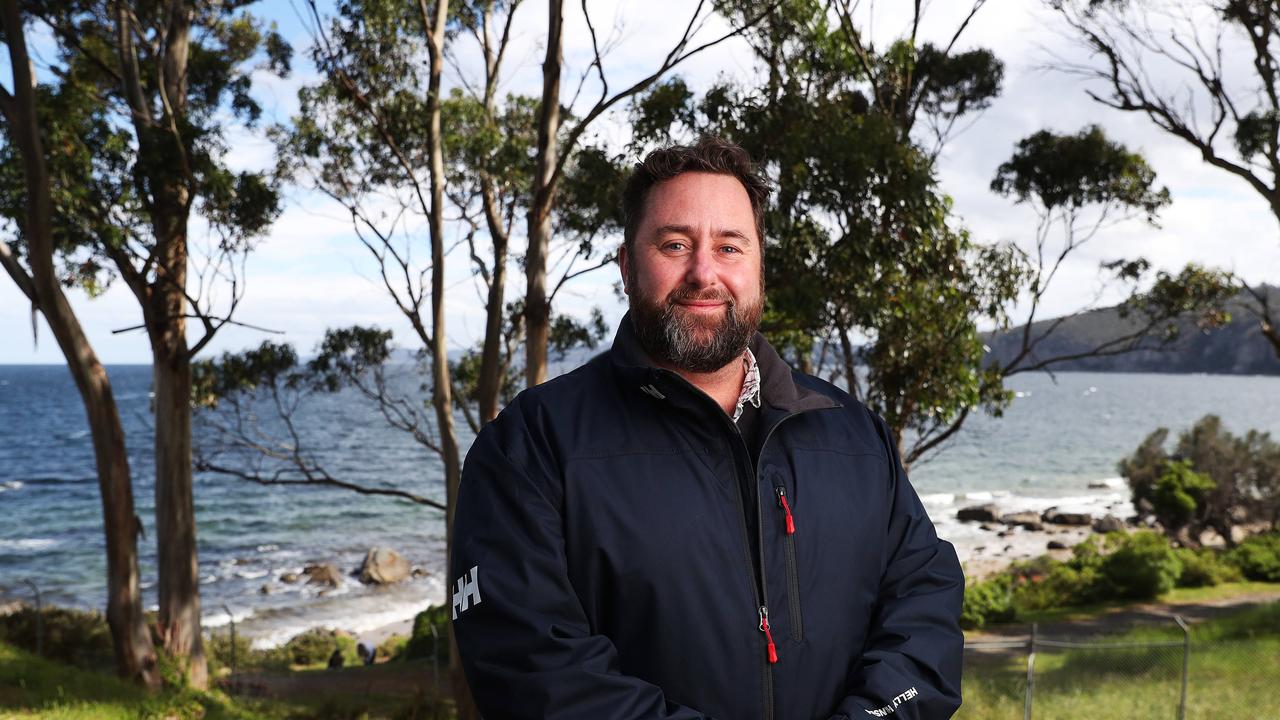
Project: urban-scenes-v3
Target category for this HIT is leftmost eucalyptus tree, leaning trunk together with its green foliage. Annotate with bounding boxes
[0,0,160,688]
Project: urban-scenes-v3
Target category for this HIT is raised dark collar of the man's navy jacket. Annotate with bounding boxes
[609,311,840,413]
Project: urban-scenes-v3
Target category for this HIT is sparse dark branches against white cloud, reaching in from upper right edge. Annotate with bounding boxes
[1046,0,1280,356]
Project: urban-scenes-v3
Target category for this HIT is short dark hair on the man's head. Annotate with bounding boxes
[622,135,769,251]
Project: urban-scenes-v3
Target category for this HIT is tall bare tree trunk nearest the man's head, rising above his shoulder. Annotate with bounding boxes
[525,0,564,387]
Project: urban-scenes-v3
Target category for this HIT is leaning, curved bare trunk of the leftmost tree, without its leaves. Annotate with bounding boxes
[0,0,160,689]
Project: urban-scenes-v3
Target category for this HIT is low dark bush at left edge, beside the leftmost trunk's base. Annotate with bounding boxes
[0,607,115,670]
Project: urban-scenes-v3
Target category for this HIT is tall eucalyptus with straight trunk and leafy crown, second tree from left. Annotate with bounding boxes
[0,0,289,687]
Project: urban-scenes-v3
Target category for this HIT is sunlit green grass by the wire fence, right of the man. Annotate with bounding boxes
[956,602,1280,720]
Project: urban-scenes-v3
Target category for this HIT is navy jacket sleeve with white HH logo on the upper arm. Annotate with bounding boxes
[445,400,707,720]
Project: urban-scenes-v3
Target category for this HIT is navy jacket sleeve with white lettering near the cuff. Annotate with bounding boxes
[833,418,964,720]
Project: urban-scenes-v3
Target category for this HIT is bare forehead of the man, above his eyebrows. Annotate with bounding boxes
[640,172,755,237]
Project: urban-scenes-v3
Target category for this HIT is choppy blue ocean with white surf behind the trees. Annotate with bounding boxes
[0,365,1280,647]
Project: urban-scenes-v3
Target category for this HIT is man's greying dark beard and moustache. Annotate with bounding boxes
[630,278,764,373]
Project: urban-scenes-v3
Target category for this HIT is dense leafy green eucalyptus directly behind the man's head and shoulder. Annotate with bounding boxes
[632,0,1221,464]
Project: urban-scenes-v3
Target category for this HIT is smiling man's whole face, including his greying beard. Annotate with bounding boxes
[620,173,764,373]
